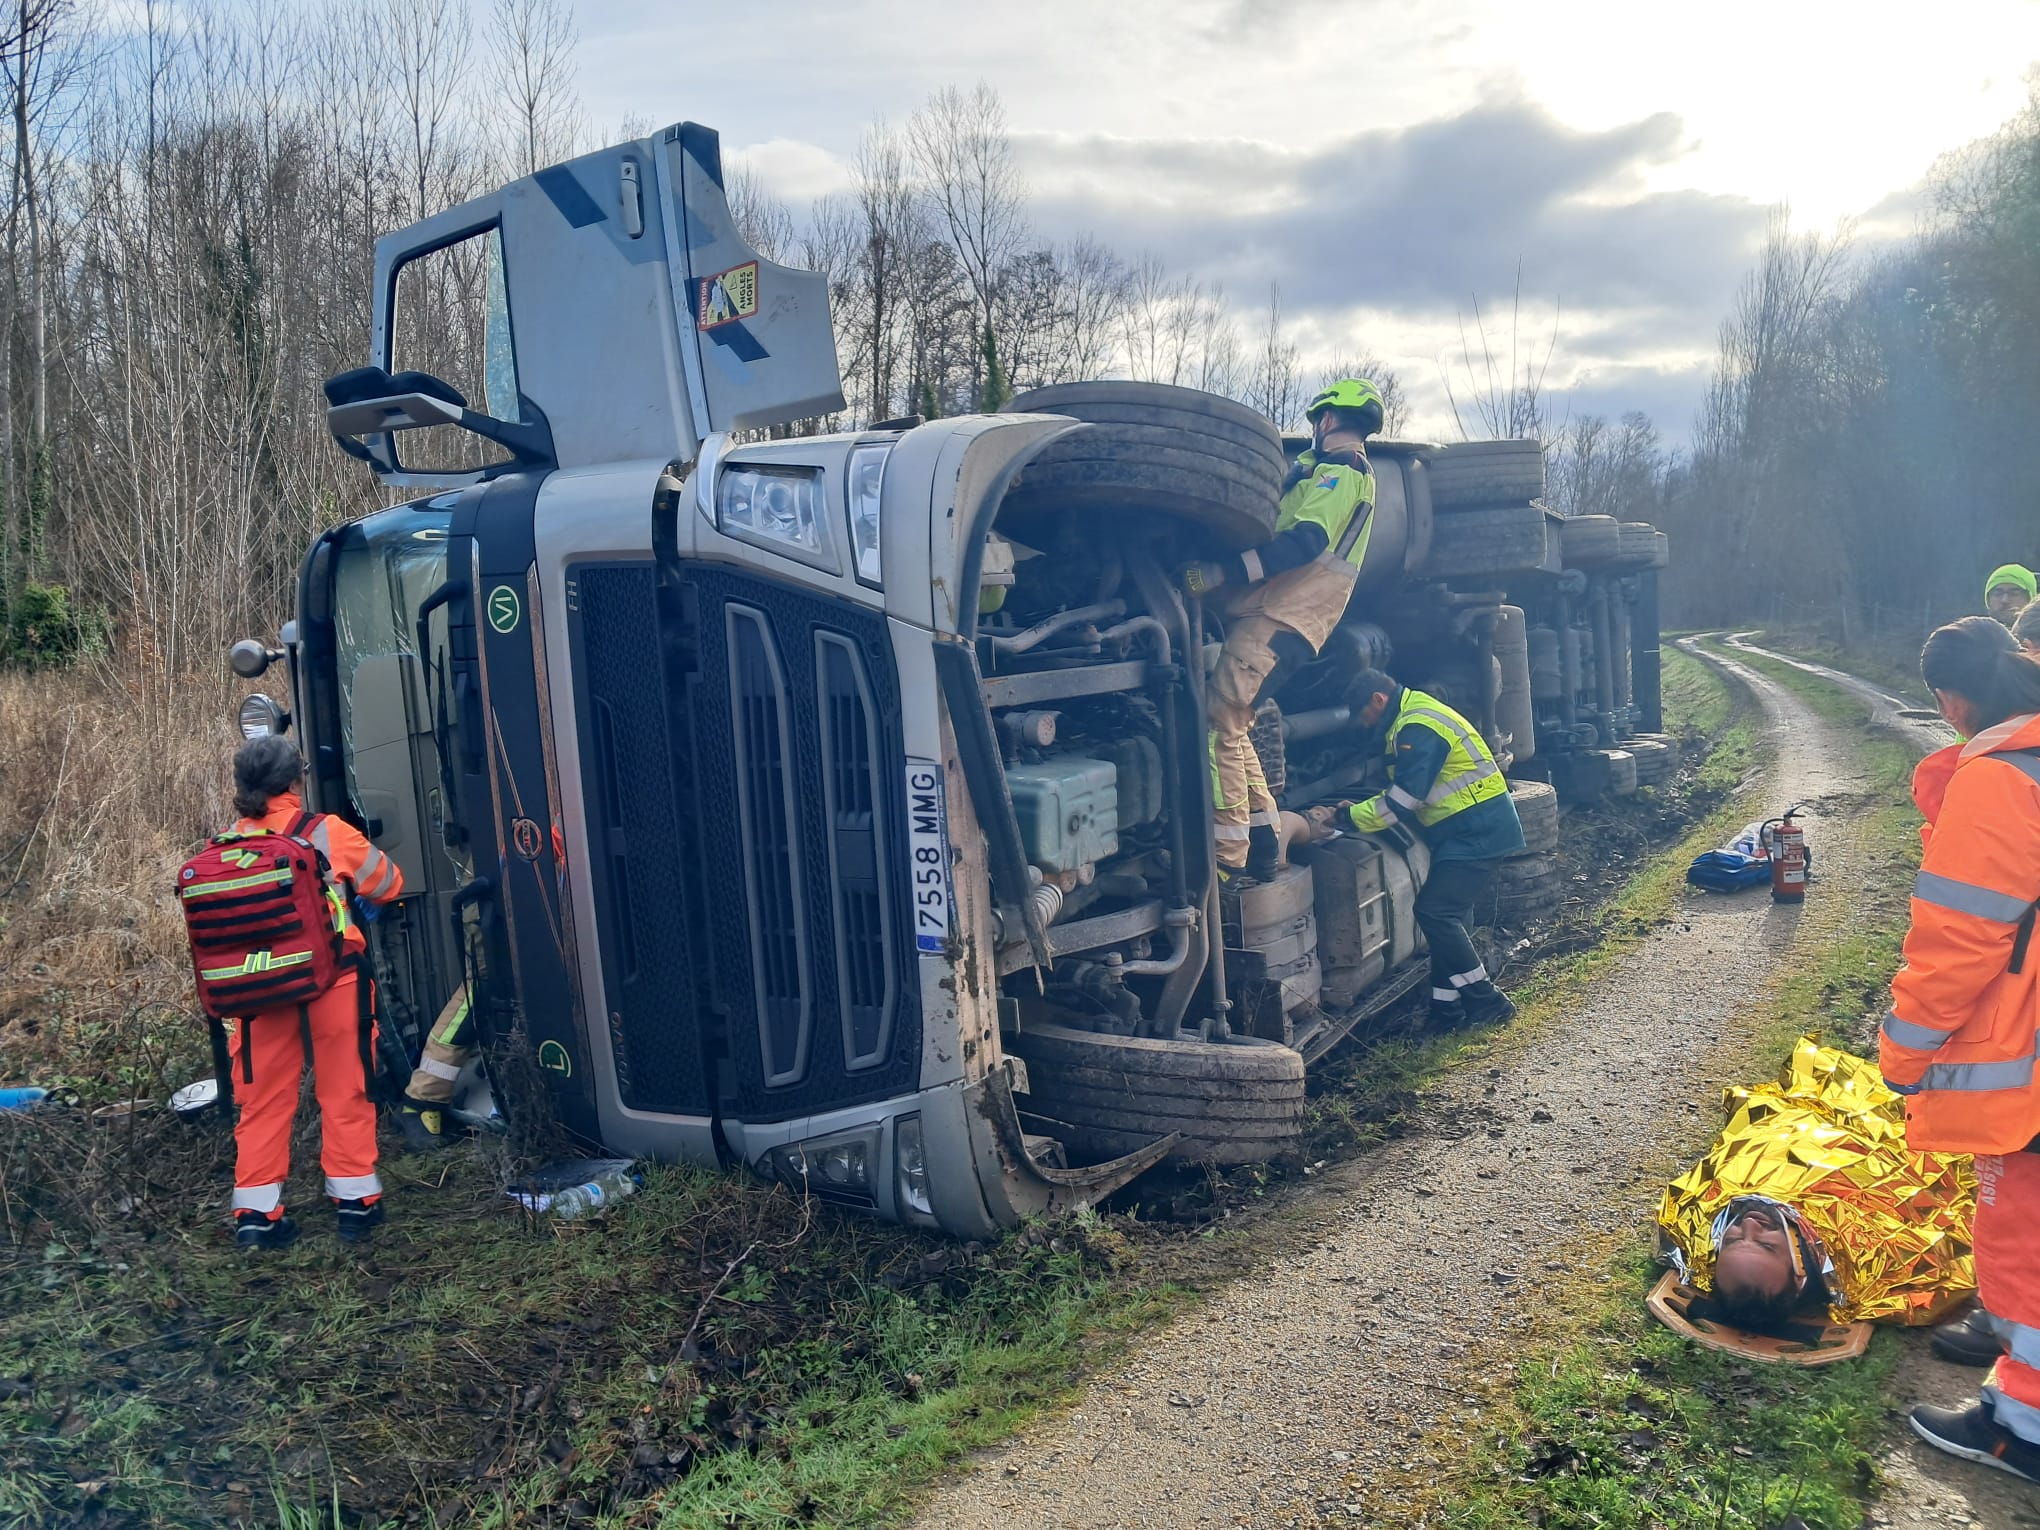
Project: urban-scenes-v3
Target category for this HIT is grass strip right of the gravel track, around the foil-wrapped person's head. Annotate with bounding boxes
[1436,653,1918,1530]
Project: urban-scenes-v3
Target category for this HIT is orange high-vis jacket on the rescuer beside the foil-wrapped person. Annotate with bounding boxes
[1877,714,2040,1153]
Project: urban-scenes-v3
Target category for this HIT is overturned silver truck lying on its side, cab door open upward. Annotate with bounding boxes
[241,124,1665,1236]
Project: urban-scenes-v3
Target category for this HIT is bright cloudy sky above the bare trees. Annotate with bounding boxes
[579,0,2040,439]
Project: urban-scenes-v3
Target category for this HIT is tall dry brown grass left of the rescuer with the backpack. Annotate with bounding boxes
[0,671,239,1104]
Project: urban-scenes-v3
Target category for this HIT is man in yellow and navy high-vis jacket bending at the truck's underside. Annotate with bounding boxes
[1338,669,1524,1030]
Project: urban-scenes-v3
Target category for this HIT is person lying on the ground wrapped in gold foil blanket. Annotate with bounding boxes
[1659,1036,1975,1338]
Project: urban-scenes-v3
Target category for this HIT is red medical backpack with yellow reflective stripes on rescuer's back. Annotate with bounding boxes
[177,814,345,1020]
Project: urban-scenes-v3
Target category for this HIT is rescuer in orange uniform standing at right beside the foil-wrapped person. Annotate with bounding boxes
[1879,616,2040,1483]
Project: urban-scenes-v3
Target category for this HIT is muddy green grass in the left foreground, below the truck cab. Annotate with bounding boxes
[0,1132,1183,1526]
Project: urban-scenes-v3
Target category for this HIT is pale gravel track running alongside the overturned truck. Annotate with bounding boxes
[916,640,2040,1530]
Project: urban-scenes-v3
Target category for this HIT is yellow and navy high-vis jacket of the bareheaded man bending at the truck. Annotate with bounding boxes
[1350,685,1524,861]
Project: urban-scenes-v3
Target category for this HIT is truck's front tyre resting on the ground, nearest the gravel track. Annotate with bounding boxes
[1008,1024,1304,1163]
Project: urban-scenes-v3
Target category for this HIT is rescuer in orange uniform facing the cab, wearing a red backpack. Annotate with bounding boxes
[228,734,404,1248]
